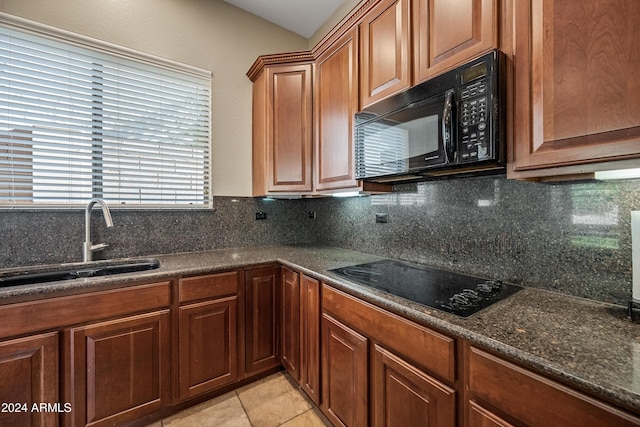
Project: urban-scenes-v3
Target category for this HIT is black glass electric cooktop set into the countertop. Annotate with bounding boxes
[329,260,522,317]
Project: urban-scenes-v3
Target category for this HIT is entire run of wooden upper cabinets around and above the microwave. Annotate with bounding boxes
[247,0,640,189]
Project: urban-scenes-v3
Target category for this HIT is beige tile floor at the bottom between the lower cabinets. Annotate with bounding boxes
[148,372,331,427]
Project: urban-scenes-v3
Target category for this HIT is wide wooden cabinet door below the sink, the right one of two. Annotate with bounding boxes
[64,310,171,426]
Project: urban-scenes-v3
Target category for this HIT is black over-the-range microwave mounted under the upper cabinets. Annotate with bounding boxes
[354,50,506,182]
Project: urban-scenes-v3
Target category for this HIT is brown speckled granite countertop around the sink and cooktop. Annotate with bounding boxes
[0,246,640,414]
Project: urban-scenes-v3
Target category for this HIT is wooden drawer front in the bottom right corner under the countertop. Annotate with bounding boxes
[466,346,640,427]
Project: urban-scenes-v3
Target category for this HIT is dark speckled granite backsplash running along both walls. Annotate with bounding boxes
[0,176,640,301]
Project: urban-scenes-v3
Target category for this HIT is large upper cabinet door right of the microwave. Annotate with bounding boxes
[510,0,640,178]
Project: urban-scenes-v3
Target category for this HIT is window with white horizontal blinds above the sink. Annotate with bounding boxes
[0,15,211,207]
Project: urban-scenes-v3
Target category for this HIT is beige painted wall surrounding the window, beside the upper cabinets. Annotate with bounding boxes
[0,0,308,196]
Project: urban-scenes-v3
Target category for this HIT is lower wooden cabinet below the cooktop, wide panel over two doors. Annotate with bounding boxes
[321,285,457,426]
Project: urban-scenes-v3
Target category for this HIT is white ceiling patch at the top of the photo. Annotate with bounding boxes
[224,0,346,39]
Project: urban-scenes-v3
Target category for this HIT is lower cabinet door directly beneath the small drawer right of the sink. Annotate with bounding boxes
[179,296,238,399]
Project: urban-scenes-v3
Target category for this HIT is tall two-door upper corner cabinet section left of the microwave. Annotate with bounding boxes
[247,34,390,197]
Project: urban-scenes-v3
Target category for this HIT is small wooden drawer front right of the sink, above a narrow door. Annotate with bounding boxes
[179,271,239,303]
